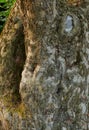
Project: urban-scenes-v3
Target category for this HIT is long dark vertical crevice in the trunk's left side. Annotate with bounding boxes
[11,25,26,104]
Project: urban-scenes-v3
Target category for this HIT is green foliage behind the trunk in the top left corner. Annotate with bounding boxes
[0,0,15,32]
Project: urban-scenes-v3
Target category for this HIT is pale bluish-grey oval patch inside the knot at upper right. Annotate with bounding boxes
[65,15,73,33]
